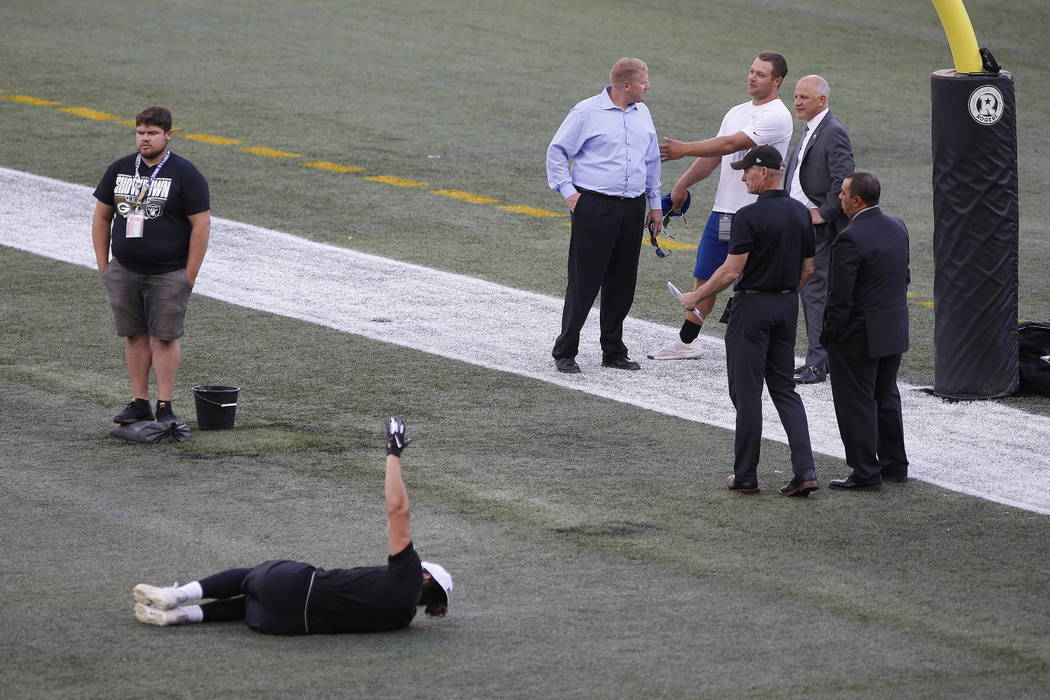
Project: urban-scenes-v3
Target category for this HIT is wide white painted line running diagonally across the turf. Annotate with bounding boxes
[6,168,1050,514]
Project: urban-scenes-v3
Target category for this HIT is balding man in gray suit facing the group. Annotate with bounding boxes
[784,76,854,384]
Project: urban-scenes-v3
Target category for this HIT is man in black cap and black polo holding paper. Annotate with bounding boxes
[681,146,817,496]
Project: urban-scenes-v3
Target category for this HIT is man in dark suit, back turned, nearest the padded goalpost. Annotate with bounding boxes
[821,172,910,491]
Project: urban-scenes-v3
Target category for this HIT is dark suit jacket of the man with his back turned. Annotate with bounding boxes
[820,207,910,359]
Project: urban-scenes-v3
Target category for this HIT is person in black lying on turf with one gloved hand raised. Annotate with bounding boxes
[131,418,453,635]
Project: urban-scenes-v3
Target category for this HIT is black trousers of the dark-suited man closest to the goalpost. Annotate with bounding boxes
[827,330,908,484]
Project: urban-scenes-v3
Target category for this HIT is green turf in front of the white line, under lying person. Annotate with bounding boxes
[0,251,1050,698]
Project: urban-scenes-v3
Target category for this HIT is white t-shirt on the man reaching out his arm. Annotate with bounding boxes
[711,98,794,214]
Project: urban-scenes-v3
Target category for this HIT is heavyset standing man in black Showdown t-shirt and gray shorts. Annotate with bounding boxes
[91,105,211,423]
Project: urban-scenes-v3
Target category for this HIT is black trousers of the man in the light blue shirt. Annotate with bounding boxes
[551,192,646,359]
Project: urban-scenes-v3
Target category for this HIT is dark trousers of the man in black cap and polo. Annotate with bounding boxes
[726,292,816,486]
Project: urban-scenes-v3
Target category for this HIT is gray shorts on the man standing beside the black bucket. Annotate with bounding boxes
[102,258,193,340]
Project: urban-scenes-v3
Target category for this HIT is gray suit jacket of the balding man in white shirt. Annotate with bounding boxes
[784,112,854,238]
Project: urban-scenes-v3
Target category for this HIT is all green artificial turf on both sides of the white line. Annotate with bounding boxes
[6,0,1050,698]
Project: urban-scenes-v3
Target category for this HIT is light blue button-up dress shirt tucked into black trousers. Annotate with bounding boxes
[547,86,660,210]
